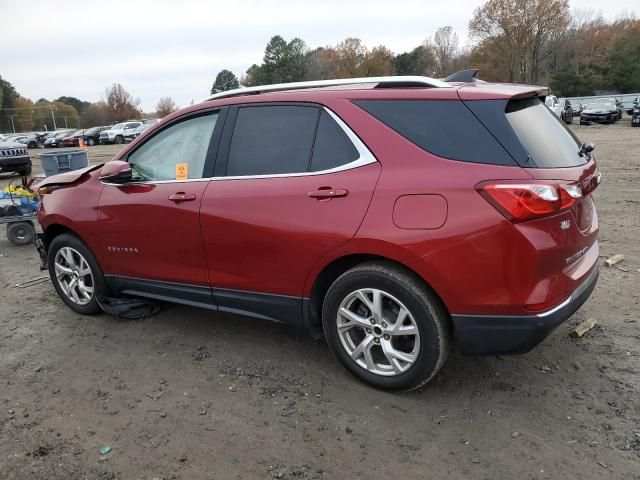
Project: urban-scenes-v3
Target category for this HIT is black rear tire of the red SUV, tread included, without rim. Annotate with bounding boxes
[322,262,451,391]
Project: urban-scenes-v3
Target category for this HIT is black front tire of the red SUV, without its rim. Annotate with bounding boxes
[47,233,109,315]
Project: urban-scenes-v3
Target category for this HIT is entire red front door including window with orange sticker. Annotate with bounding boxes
[98,112,223,297]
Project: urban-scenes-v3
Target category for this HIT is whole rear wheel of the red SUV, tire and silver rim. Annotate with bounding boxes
[322,262,451,390]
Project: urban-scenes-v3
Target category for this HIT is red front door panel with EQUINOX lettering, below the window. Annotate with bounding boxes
[92,181,209,285]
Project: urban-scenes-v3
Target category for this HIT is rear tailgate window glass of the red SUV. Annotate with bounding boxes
[505,98,587,168]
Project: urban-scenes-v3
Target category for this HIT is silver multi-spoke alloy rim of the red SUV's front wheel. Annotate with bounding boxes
[54,247,94,305]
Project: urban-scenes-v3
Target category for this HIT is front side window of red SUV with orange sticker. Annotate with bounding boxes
[129,113,218,181]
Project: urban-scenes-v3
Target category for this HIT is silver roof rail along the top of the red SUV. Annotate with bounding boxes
[207,75,451,100]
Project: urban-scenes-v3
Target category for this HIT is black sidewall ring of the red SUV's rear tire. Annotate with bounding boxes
[322,270,444,390]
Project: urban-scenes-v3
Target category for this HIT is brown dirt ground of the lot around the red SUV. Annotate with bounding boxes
[0,118,640,480]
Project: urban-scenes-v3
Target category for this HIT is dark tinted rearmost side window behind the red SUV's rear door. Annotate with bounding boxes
[356,100,515,165]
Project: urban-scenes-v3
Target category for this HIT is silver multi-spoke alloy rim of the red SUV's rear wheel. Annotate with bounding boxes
[336,288,420,376]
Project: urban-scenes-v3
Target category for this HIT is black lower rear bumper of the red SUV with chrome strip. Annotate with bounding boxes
[451,267,599,355]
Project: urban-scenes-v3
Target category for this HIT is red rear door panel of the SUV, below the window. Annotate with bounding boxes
[200,163,380,296]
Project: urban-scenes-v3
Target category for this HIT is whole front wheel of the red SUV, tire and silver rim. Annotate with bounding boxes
[47,233,107,315]
